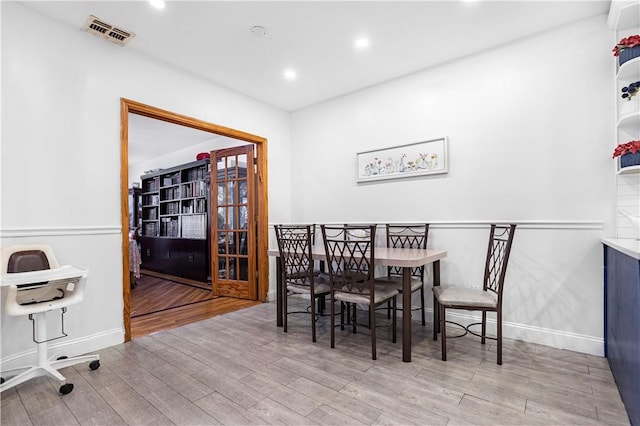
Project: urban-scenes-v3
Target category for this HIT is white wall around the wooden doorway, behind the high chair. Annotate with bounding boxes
[0,2,290,366]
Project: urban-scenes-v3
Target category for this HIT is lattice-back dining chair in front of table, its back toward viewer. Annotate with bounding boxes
[321,225,398,360]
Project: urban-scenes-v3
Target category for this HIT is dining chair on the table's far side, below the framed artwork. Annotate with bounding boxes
[384,223,429,326]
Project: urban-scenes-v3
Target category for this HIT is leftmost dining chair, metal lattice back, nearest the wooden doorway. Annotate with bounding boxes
[274,225,329,342]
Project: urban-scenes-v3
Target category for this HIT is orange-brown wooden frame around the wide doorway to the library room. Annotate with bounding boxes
[120,98,269,342]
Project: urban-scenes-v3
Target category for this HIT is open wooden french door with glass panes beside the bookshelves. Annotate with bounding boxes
[211,144,258,300]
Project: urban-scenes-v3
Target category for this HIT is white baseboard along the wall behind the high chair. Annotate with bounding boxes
[0,328,124,371]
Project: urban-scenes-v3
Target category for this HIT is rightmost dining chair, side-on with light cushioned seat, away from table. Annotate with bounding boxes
[433,224,516,365]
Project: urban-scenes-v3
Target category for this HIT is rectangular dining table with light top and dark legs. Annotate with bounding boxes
[268,244,447,362]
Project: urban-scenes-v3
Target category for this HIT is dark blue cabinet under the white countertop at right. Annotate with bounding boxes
[604,245,640,425]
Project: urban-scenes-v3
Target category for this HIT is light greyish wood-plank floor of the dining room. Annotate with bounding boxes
[1,298,629,426]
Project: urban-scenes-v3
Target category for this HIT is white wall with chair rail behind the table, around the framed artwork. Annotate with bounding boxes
[291,15,615,354]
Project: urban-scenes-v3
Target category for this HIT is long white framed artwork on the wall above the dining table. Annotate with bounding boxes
[356,137,449,182]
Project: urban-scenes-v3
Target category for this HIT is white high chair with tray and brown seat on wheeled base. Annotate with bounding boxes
[0,245,100,395]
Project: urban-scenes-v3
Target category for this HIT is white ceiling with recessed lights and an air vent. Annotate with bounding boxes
[22,0,610,111]
